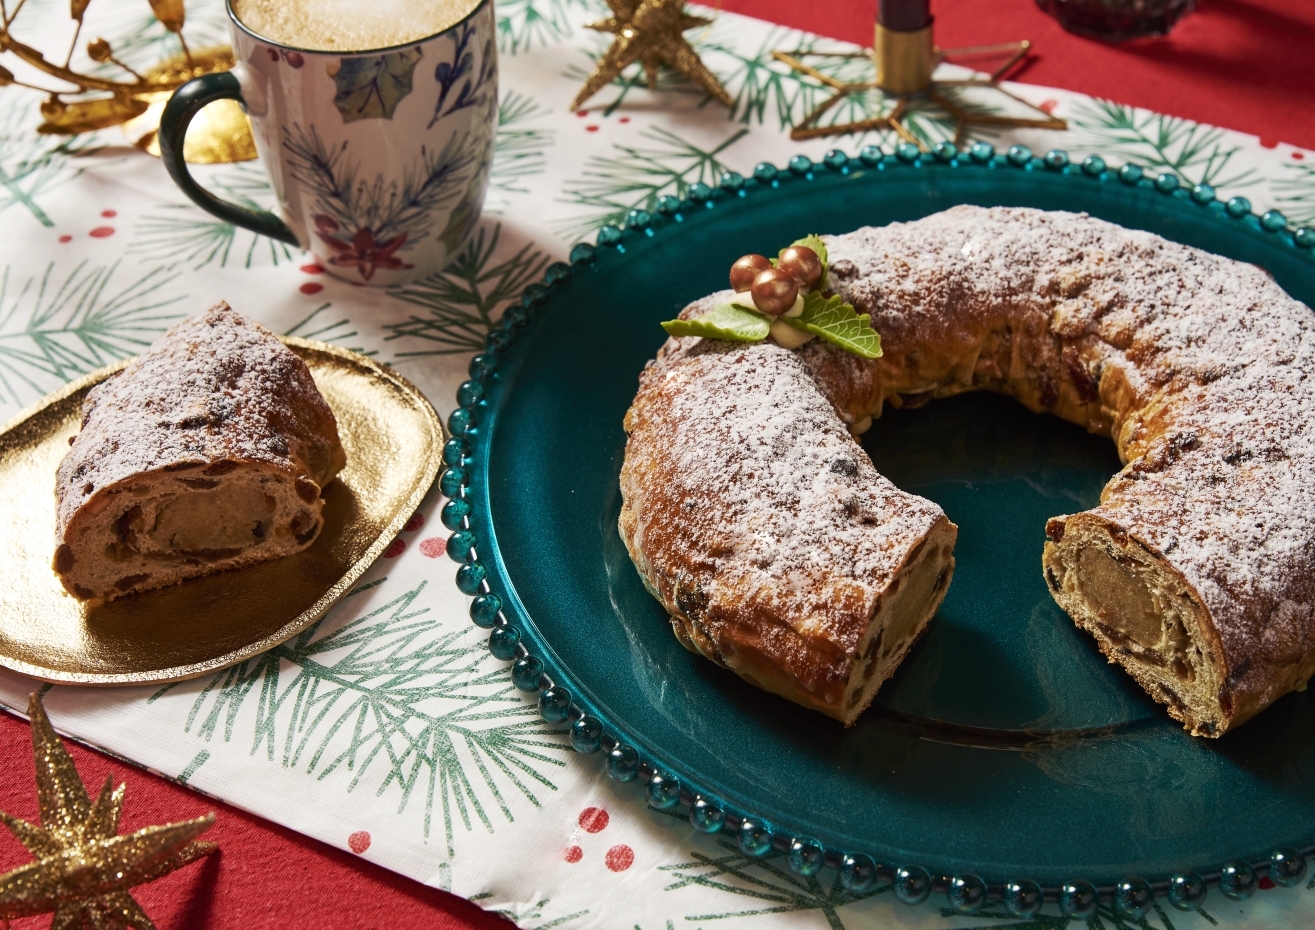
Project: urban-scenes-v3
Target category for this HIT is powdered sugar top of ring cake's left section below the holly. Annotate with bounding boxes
[622,342,943,655]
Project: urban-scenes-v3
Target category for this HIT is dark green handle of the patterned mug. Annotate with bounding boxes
[159,71,301,249]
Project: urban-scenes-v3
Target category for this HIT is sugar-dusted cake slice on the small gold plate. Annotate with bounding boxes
[54,304,346,600]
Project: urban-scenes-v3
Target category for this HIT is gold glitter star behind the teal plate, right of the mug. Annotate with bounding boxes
[571,0,734,109]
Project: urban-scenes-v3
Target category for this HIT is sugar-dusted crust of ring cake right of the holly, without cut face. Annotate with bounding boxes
[827,207,1315,689]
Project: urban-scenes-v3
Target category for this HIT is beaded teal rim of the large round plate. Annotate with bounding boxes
[439,142,1315,919]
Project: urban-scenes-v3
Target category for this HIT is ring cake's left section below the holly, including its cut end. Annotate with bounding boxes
[619,343,956,723]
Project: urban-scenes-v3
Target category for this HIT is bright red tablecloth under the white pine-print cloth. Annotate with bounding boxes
[0,0,1315,930]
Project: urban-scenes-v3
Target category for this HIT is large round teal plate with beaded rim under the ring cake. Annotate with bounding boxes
[443,146,1315,913]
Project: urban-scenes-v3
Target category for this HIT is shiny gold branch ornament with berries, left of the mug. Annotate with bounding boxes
[0,0,256,164]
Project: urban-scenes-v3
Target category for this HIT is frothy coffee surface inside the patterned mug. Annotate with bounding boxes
[231,0,480,51]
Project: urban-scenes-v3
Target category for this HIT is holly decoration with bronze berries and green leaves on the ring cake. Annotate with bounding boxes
[661,235,881,359]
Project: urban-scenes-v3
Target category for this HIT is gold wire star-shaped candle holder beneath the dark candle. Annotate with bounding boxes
[772,39,1068,151]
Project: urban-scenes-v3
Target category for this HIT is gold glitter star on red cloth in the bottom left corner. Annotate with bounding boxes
[0,695,218,930]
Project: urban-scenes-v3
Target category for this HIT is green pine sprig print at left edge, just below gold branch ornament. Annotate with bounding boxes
[0,96,97,226]
